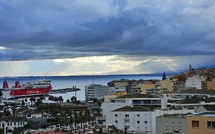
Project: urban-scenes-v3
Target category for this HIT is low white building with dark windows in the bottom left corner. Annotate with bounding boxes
[0,117,27,134]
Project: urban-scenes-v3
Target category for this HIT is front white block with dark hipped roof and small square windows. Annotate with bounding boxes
[109,106,153,134]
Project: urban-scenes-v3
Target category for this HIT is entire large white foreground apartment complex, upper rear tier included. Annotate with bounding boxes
[101,94,194,134]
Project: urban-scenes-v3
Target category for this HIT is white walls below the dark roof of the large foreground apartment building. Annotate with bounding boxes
[105,106,194,134]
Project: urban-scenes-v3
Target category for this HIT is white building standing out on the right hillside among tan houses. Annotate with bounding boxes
[186,75,204,89]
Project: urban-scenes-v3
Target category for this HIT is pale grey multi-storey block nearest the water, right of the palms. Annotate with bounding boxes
[85,84,110,100]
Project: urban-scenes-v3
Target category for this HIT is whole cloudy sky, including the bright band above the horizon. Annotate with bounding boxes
[0,0,215,77]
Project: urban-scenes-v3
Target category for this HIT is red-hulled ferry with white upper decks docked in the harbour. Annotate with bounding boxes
[3,80,52,97]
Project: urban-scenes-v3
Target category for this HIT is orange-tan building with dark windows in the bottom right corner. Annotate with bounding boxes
[186,112,215,134]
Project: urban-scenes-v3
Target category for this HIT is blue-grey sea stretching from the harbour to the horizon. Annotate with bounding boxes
[0,74,162,101]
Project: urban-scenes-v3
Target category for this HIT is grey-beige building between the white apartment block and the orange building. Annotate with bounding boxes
[156,114,188,134]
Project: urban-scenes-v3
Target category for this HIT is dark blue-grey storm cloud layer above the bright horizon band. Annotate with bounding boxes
[0,0,215,60]
